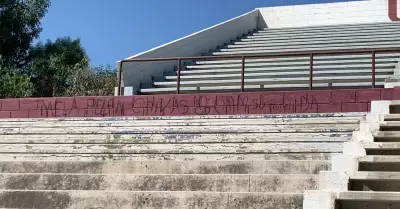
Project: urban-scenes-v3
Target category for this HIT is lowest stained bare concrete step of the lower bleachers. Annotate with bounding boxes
[0,191,303,209]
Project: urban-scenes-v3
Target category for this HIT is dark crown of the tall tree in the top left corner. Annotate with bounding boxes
[0,0,50,68]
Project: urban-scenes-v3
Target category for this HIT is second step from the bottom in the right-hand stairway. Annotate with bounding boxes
[350,172,400,192]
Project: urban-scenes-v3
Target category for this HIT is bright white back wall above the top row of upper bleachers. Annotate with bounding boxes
[259,0,400,28]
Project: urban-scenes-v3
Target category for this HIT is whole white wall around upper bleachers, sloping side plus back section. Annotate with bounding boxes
[117,0,399,94]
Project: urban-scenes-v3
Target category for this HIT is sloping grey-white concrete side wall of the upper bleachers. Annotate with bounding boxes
[117,10,259,92]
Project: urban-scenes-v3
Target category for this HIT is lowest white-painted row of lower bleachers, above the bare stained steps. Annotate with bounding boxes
[0,143,343,154]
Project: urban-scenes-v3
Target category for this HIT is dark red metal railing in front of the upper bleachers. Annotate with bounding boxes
[117,47,400,95]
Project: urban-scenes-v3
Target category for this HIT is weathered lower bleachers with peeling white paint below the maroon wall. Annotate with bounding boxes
[0,113,364,209]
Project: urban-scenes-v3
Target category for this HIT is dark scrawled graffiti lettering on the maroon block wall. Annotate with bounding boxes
[31,94,318,117]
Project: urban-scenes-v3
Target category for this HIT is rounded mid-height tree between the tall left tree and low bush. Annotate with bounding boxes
[29,37,89,97]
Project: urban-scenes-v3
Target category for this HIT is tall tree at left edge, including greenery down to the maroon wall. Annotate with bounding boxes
[0,0,50,98]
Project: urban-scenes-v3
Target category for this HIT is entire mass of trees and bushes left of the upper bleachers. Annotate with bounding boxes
[0,0,117,98]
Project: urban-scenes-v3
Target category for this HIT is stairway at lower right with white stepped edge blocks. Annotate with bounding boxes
[304,101,400,209]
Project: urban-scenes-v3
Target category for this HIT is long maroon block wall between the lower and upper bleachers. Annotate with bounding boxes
[0,88,400,118]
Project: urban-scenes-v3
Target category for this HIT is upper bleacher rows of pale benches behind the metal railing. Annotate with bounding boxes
[141,23,400,94]
